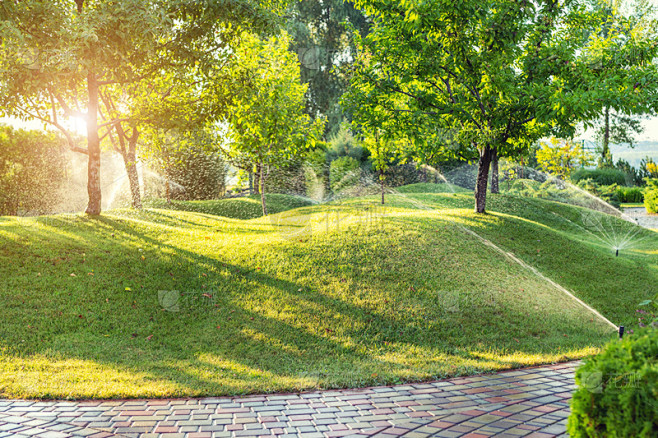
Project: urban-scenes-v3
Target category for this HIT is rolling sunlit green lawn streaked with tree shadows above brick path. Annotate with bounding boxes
[0,193,658,398]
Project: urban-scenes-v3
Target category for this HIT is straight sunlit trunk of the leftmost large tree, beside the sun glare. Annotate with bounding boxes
[86,72,101,215]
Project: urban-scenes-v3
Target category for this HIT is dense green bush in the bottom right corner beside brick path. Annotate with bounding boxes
[568,329,658,437]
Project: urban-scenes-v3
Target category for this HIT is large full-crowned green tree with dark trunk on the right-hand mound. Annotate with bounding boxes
[345,0,658,213]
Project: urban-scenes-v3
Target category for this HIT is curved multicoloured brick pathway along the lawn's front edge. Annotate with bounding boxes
[0,362,578,438]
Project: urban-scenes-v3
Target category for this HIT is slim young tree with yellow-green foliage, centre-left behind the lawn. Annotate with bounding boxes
[226,34,324,215]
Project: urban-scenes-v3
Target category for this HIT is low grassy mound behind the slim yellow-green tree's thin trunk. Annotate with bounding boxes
[146,193,313,219]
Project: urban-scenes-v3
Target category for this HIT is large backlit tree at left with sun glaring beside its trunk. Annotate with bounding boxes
[0,0,281,215]
